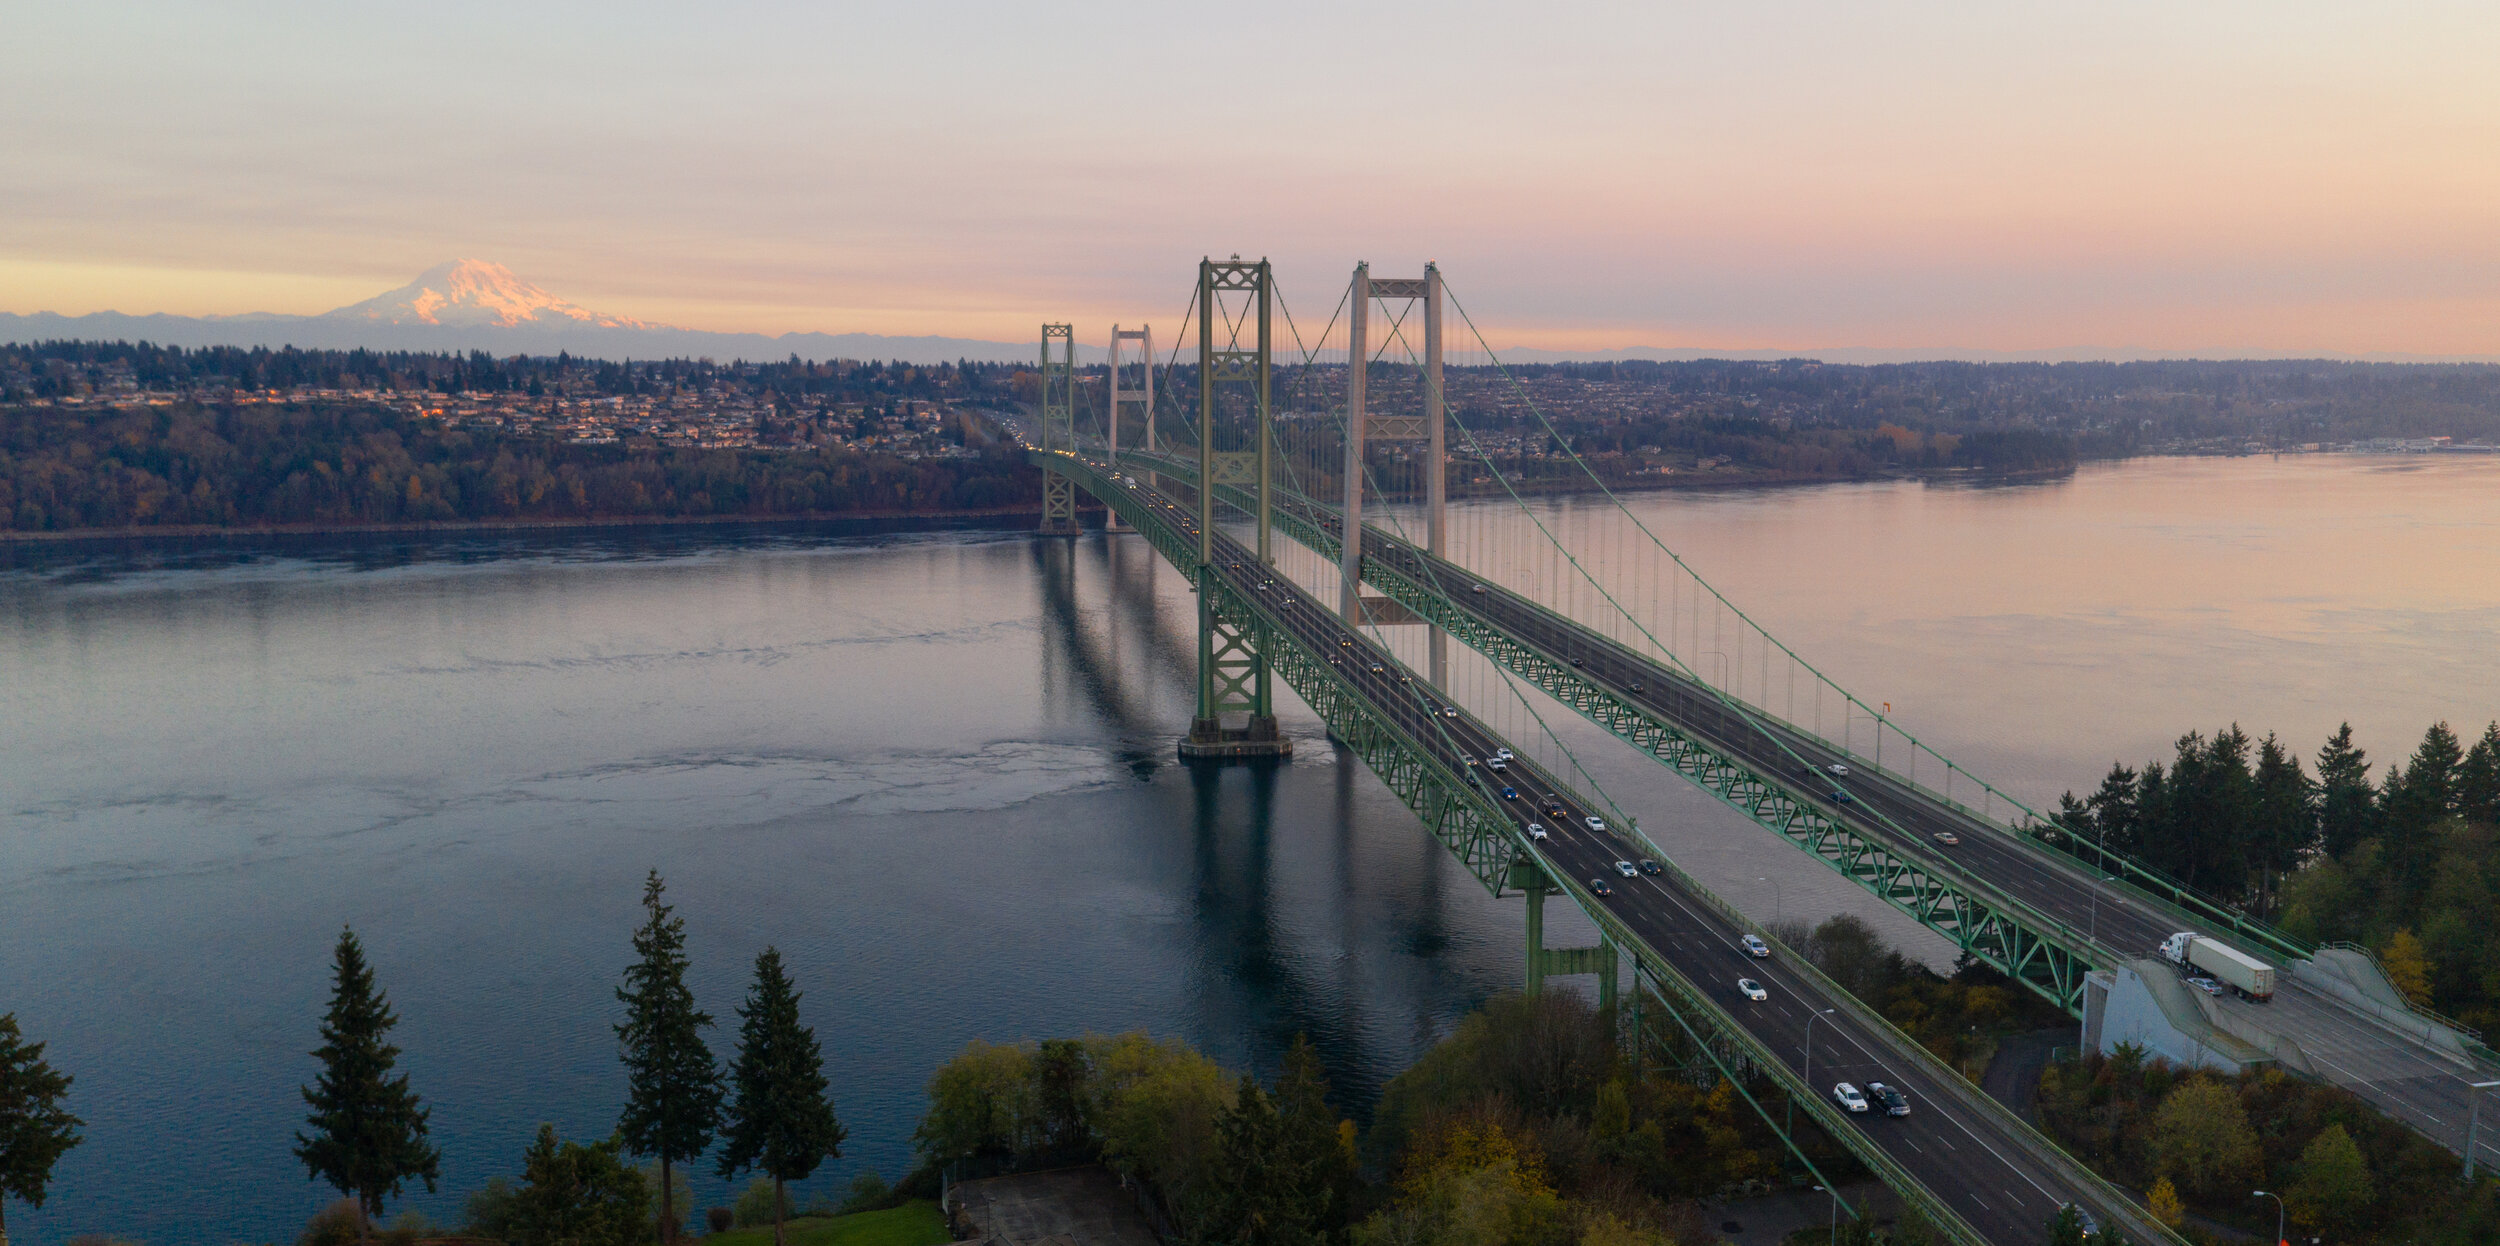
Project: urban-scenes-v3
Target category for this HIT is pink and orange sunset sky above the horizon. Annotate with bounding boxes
[0,0,2500,355]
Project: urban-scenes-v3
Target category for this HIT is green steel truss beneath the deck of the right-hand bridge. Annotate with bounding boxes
[1125,452,2108,1016]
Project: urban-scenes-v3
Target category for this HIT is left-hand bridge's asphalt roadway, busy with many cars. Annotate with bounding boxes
[1115,485,2145,1243]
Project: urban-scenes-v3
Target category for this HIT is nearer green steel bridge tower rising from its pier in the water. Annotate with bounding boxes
[1180,255,1293,758]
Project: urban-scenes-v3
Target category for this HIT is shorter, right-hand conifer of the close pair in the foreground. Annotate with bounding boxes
[720,948,850,1246]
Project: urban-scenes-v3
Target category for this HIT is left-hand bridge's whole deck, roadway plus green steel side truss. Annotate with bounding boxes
[1033,453,2178,1246]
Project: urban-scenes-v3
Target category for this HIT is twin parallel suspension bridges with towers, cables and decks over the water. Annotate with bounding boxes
[1023,258,2500,1243]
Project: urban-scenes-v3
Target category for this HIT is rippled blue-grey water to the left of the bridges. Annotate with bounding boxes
[0,530,1550,1246]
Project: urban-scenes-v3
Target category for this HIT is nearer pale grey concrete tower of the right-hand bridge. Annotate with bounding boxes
[1338,260,1450,691]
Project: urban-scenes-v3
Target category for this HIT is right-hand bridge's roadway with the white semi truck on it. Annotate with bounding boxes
[1288,498,2500,1163]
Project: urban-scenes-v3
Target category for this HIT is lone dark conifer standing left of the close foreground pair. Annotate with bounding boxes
[295,928,443,1236]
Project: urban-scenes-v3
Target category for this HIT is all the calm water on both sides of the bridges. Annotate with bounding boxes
[0,458,2500,1246]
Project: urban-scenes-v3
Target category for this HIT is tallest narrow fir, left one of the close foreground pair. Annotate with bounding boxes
[618,871,723,1241]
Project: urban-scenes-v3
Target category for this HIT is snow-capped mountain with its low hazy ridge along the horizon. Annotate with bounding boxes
[0,260,1075,363]
